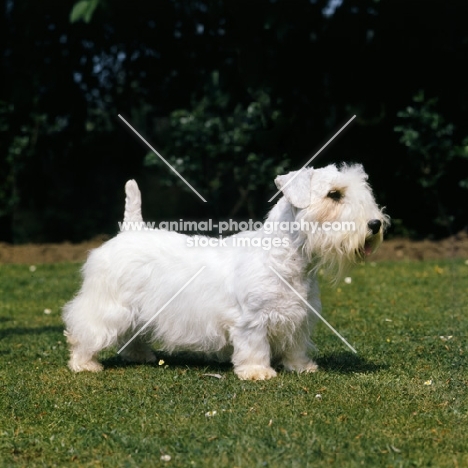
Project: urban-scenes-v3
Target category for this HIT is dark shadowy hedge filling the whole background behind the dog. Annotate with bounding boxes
[0,0,468,242]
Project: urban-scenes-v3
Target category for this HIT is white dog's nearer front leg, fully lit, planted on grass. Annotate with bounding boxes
[231,326,276,380]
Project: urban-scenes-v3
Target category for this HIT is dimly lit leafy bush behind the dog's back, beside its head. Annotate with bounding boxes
[145,72,289,219]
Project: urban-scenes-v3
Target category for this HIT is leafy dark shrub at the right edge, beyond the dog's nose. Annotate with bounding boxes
[395,91,468,238]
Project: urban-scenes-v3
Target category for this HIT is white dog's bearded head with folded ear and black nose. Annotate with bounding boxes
[275,164,390,278]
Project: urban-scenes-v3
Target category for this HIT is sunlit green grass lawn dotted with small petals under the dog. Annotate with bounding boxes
[0,260,468,468]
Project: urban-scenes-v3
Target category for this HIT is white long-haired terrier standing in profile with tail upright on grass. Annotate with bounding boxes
[63,164,389,380]
